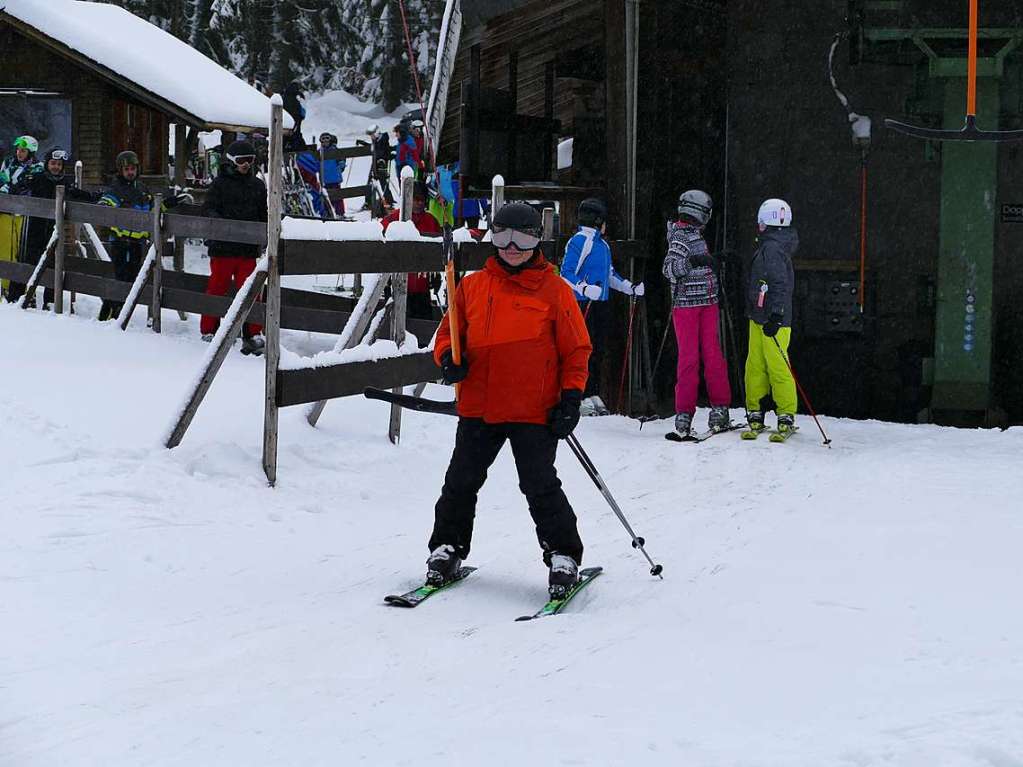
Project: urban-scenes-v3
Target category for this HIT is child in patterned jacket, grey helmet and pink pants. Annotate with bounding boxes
[662,189,731,437]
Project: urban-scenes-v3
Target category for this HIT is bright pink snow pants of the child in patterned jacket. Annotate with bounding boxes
[671,304,731,413]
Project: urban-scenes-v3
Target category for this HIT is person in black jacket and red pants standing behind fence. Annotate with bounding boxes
[199,141,267,355]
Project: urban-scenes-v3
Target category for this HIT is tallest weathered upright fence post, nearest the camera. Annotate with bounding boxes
[263,96,284,487]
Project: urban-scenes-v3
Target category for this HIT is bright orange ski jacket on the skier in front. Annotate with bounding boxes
[434,257,592,423]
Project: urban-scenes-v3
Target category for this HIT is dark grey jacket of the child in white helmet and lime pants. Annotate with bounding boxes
[746,226,799,327]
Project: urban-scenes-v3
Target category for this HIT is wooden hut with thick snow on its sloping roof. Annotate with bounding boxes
[0,0,290,183]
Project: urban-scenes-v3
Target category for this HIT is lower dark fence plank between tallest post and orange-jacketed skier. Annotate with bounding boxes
[277,352,441,407]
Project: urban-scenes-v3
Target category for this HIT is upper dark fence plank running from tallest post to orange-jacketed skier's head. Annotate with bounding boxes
[280,239,494,275]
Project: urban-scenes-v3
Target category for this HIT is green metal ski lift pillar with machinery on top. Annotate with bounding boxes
[849,0,1023,425]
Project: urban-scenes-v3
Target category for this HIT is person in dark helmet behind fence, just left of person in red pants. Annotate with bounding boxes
[99,149,152,320]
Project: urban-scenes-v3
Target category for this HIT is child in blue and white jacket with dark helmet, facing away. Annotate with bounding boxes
[562,197,646,415]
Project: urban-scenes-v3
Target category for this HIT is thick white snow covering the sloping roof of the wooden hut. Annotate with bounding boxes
[0,0,293,130]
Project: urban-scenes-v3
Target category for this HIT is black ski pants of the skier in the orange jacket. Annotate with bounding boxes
[430,418,582,565]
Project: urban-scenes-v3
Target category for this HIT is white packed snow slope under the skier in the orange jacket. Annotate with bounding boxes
[0,298,1023,767]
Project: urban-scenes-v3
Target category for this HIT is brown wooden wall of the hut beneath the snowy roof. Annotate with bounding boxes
[0,22,169,184]
